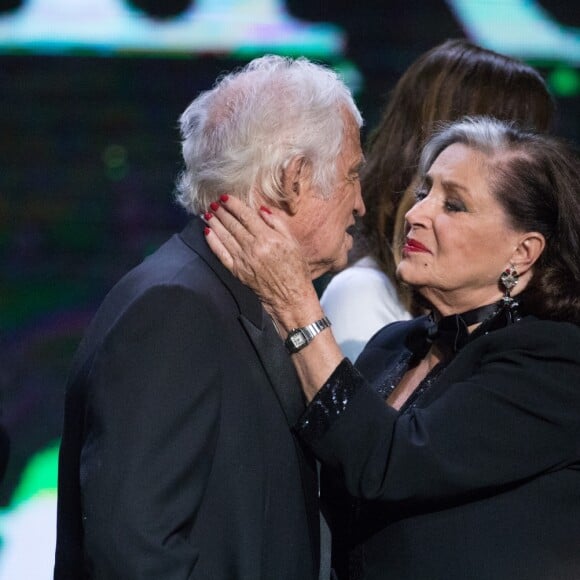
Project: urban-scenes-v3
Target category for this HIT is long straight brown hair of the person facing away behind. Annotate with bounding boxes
[358,39,554,291]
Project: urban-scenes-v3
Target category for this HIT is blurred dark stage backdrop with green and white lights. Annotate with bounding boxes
[0,0,580,580]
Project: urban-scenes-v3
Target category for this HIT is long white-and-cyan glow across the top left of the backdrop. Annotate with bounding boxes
[0,0,344,57]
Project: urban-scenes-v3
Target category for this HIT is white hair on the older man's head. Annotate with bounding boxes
[177,55,362,214]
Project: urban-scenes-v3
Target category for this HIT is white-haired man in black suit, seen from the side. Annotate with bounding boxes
[55,56,364,580]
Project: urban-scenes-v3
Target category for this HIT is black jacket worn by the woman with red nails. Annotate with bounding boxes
[298,316,580,580]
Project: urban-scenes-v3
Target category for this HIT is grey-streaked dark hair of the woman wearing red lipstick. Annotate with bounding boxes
[419,117,580,324]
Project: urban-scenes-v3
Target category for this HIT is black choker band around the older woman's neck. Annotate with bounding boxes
[427,300,520,353]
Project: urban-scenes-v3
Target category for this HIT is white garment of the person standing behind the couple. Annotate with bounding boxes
[320,256,411,362]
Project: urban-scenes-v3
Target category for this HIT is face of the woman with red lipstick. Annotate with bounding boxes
[397,143,521,315]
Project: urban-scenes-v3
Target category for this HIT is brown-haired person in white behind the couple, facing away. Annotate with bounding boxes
[322,40,554,361]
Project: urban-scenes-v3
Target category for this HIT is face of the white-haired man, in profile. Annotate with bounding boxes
[290,112,365,279]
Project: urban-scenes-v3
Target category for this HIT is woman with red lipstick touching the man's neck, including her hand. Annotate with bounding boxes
[207,118,580,580]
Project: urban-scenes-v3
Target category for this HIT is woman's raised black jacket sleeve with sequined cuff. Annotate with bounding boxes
[296,319,580,502]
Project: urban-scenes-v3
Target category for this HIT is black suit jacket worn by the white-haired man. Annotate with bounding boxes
[55,218,319,580]
